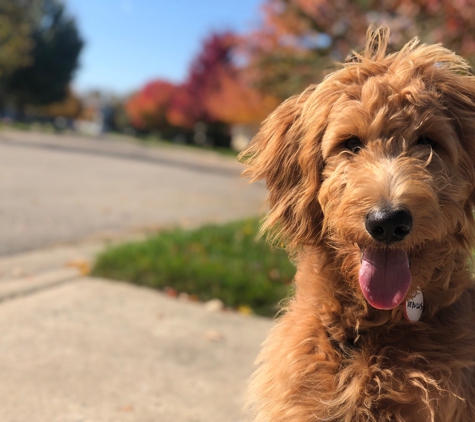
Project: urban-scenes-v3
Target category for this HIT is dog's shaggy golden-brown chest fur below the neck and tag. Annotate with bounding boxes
[253,282,475,422]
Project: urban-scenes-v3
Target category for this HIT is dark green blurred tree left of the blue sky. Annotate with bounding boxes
[5,0,83,115]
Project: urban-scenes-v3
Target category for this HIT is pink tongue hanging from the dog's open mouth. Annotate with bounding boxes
[359,248,411,309]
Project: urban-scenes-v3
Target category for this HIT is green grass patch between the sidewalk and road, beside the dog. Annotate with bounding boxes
[92,219,295,316]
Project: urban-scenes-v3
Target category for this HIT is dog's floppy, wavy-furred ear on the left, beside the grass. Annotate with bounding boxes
[240,86,322,248]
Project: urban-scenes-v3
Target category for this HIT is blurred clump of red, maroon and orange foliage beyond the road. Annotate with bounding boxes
[126,32,278,130]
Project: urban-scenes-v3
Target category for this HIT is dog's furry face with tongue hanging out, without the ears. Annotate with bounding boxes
[318,64,475,309]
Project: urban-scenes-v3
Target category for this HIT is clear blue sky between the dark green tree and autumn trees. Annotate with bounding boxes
[65,0,263,95]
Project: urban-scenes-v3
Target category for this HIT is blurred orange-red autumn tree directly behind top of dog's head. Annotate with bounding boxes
[246,0,475,98]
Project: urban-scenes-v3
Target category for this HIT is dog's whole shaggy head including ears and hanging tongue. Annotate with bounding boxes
[244,30,475,309]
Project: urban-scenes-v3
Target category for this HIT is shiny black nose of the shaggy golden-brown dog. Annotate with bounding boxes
[365,208,412,243]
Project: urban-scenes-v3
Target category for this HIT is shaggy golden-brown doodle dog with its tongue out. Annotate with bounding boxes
[242,28,475,422]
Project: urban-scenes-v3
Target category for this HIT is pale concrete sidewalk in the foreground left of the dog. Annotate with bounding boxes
[0,244,272,422]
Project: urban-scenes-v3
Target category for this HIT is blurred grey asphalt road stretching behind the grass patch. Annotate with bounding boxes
[0,131,266,256]
